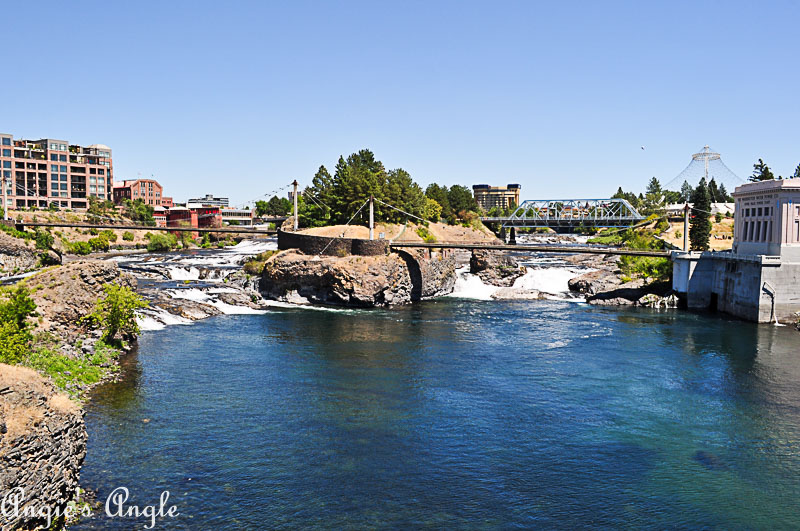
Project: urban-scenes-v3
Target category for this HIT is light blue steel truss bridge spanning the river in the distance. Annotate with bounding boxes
[481,199,645,230]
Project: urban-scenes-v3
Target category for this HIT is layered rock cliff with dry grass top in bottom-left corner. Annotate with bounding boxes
[0,364,86,529]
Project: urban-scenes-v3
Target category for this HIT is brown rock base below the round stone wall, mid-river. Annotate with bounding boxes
[259,250,412,307]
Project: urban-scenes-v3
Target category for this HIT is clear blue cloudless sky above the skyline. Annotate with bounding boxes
[0,1,800,203]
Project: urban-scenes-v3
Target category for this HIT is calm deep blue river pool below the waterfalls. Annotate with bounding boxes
[76,299,800,529]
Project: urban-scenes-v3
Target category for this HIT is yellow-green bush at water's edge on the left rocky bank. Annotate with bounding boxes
[84,284,147,342]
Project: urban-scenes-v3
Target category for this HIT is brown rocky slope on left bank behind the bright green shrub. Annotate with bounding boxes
[26,260,136,342]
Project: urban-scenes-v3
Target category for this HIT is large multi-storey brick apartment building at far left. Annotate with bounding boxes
[0,133,114,210]
